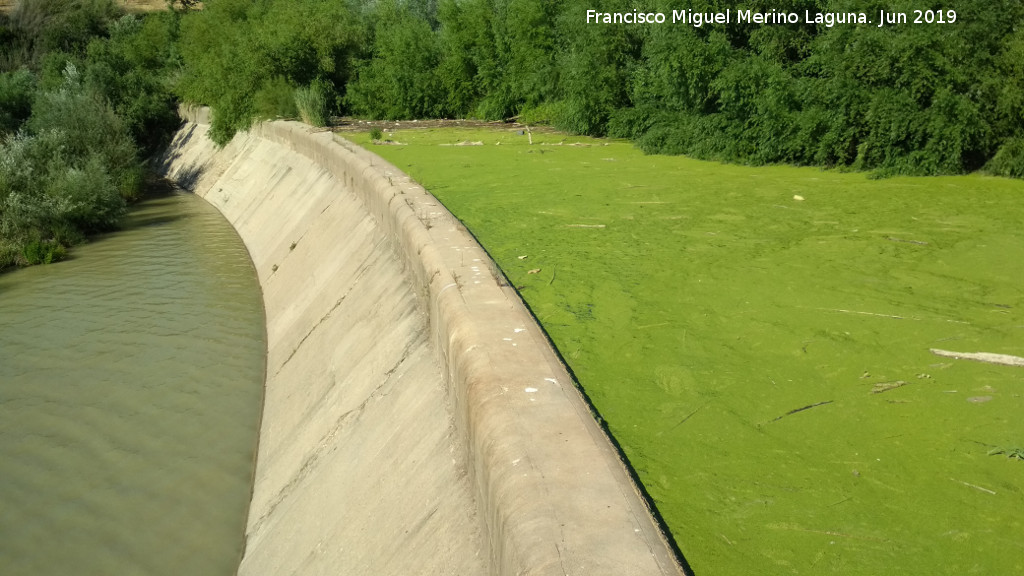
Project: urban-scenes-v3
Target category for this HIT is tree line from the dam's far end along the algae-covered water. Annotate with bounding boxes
[180,0,1024,177]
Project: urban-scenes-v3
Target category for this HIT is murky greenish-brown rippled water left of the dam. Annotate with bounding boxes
[0,188,265,576]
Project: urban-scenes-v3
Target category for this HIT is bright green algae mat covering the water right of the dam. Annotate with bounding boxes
[350,129,1024,576]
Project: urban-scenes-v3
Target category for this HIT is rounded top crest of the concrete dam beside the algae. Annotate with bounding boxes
[167,109,683,575]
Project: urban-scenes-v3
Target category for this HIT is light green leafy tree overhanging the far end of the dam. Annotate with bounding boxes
[175,0,359,143]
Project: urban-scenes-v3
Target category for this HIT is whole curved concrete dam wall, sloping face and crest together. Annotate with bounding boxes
[163,111,682,576]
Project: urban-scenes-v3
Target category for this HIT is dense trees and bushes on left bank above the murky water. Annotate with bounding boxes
[0,0,178,269]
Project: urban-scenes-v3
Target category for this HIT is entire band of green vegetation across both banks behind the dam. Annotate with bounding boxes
[0,0,1024,268]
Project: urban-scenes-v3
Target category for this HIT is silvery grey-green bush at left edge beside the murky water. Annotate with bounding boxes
[0,60,132,268]
